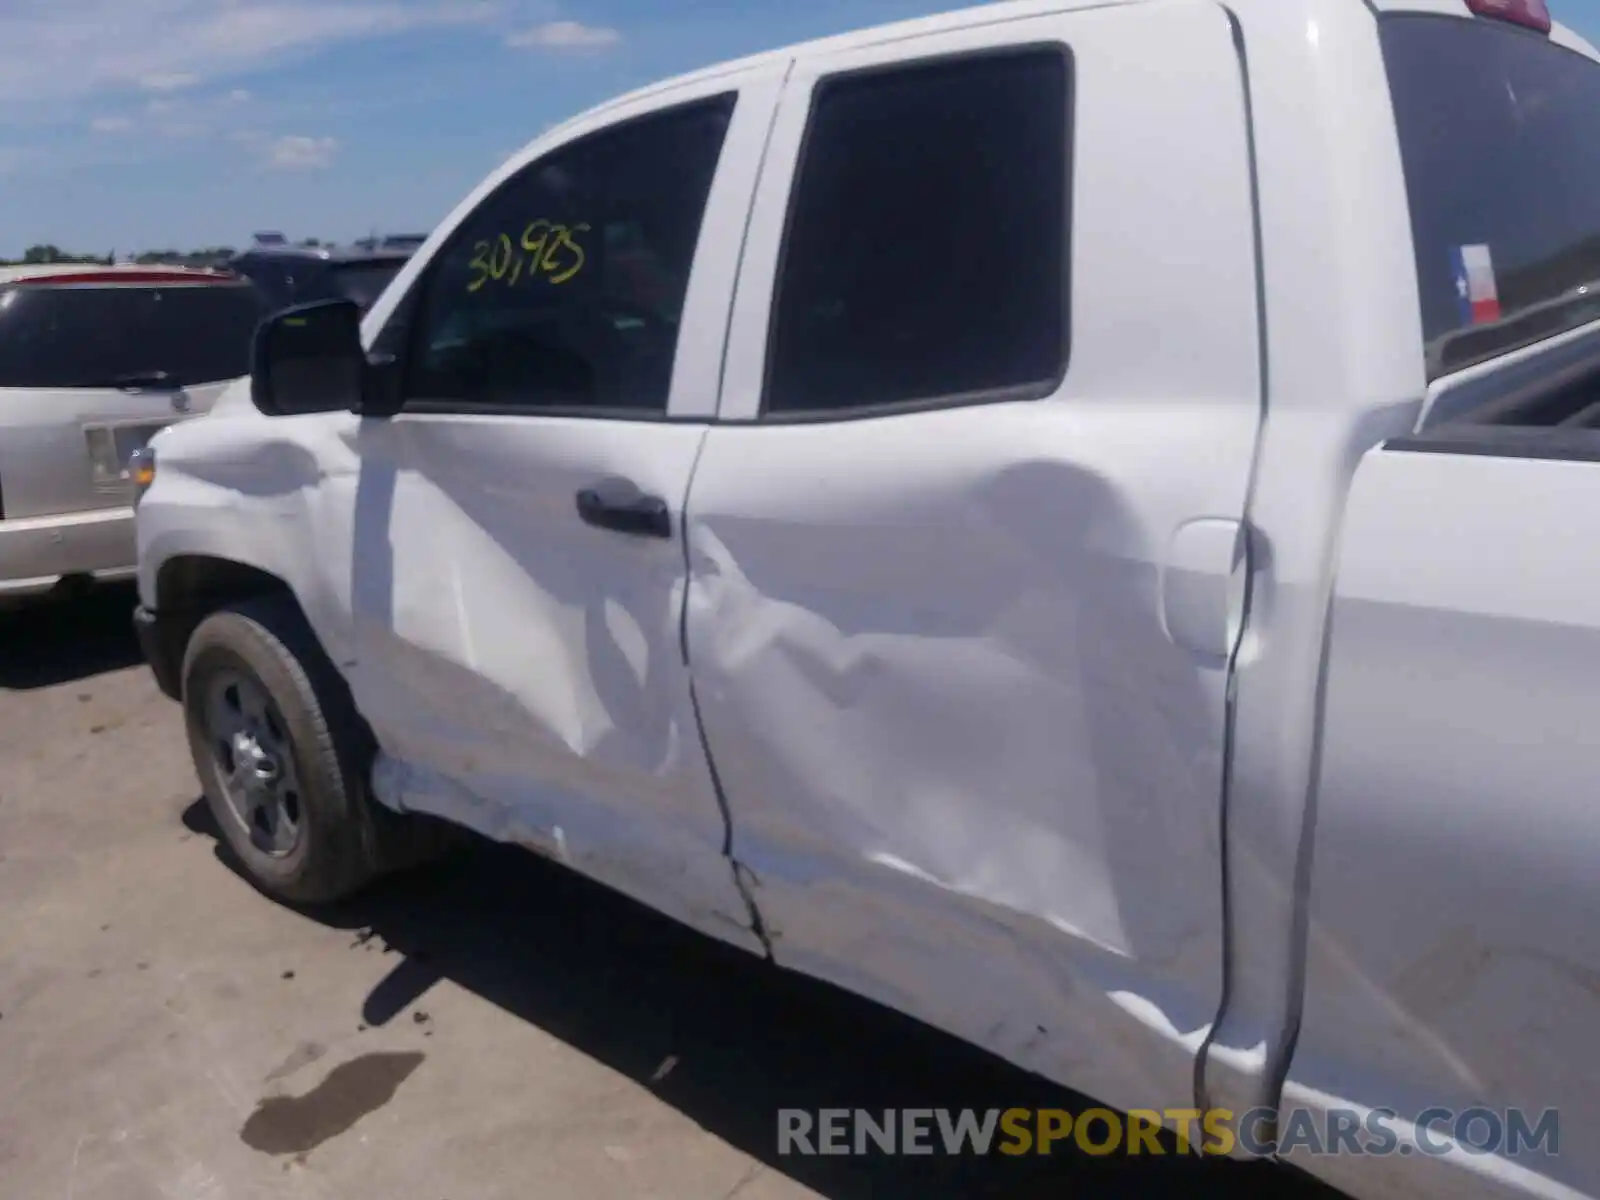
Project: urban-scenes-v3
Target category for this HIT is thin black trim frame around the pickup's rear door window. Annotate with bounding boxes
[752,38,1078,426]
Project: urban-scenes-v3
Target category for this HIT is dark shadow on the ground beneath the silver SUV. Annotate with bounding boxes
[0,584,142,691]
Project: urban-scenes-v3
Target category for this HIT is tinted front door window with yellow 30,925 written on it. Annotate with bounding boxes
[408,96,733,413]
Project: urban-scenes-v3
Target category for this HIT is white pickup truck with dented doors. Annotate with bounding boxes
[138,0,1600,1200]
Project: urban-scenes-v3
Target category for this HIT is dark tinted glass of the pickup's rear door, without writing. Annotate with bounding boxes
[765,48,1070,413]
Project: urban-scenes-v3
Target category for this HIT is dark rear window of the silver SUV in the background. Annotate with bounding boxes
[0,283,264,387]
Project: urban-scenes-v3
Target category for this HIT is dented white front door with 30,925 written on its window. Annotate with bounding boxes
[329,72,778,952]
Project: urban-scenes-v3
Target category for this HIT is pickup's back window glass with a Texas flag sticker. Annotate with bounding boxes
[1381,14,1600,379]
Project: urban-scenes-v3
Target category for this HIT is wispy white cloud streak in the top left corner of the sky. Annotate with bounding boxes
[0,0,509,106]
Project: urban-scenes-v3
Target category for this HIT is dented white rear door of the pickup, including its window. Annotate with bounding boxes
[686,3,1261,1126]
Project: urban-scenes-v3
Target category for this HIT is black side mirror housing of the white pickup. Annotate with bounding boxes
[250,299,377,416]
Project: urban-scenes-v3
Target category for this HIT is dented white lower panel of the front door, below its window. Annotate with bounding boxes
[358,419,762,954]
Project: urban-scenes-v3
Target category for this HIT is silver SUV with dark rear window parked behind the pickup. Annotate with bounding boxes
[0,266,266,605]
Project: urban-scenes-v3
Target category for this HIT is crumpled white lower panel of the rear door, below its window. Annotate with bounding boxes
[688,419,1222,1107]
